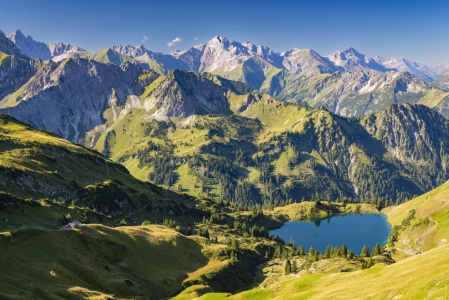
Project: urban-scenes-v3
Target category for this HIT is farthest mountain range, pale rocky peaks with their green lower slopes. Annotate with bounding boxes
[5,31,448,116]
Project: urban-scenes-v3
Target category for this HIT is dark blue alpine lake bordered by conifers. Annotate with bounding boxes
[270,214,391,255]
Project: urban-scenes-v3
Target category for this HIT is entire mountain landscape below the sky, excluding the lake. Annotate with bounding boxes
[0,27,449,299]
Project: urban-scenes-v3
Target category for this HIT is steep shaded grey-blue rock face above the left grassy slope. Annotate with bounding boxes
[0,58,144,141]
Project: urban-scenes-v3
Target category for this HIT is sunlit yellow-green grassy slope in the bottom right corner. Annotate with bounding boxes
[187,245,449,299]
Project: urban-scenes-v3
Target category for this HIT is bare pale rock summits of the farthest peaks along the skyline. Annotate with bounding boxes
[7,30,449,82]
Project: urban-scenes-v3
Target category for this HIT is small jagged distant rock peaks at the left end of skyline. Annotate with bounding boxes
[7,30,86,61]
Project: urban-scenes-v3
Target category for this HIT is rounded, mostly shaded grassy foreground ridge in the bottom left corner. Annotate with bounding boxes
[0,225,218,299]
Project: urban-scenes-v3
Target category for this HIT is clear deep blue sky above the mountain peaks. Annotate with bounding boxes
[0,0,449,66]
